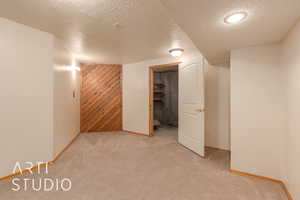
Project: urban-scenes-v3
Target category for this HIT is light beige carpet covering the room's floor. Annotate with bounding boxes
[0,129,286,200]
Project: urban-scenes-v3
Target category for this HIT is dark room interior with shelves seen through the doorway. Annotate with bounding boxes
[153,67,178,128]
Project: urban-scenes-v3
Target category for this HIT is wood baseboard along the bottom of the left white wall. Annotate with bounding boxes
[0,133,80,181]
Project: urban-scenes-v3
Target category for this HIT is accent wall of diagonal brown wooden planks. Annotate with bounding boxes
[80,64,122,132]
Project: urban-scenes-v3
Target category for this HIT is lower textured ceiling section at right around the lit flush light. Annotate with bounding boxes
[161,0,300,63]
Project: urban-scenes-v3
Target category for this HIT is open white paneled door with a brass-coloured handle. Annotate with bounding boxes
[178,58,205,157]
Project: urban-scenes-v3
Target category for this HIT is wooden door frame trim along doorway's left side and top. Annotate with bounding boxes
[148,62,181,136]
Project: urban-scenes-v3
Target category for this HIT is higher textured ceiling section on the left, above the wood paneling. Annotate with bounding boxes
[0,0,196,63]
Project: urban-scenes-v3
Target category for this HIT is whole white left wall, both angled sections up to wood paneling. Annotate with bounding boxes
[0,18,80,177]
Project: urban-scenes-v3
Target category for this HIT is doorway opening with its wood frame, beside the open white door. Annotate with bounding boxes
[149,63,179,137]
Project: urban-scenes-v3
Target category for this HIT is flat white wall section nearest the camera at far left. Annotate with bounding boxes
[0,18,53,177]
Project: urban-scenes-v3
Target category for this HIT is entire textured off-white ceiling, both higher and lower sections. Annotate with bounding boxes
[0,0,300,64]
